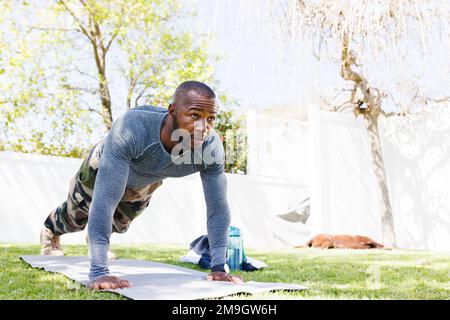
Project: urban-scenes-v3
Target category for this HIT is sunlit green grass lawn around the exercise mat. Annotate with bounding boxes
[0,244,450,300]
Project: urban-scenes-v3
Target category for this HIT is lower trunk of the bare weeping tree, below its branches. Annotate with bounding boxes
[364,114,397,247]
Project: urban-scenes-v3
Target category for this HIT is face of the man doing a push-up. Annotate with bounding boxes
[171,91,218,149]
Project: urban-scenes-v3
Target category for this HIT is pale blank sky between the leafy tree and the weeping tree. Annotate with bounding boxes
[190,0,316,108]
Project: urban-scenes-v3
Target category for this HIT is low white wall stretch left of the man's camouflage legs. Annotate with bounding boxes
[0,152,81,243]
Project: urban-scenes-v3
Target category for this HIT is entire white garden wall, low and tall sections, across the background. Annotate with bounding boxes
[0,108,450,251]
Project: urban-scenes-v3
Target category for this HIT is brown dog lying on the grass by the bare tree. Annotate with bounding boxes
[295,234,384,249]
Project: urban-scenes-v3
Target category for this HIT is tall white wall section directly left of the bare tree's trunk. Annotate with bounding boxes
[309,108,381,241]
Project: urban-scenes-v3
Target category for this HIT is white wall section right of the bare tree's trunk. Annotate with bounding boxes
[380,108,450,251]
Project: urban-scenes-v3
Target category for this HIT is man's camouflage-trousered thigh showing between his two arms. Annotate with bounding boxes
[113,181,162,233]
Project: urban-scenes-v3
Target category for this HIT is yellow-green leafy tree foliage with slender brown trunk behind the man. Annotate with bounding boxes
[0,0,216,154]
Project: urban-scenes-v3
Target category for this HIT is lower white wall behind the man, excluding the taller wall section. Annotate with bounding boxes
[0,152,309,247]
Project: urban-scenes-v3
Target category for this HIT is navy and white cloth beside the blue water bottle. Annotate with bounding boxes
[180,235,267,271]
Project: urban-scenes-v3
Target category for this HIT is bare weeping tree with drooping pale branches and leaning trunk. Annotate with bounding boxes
[285,0,450,246]
